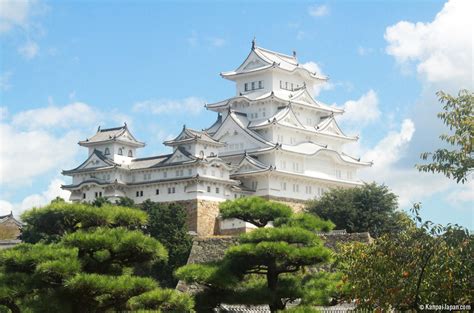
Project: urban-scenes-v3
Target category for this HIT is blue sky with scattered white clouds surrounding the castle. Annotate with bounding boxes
[0,0,474,230]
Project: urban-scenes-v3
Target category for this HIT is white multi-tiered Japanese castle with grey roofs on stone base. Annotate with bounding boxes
[62,41,371,236]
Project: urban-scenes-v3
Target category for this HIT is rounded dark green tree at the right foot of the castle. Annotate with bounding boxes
[306,183,408,237]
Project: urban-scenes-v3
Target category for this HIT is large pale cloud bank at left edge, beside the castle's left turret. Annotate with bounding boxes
[0,102,129,187]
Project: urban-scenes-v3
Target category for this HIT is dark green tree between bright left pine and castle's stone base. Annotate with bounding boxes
[141,200,192,288]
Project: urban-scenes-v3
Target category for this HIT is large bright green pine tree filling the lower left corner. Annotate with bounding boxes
[0,202,193,312]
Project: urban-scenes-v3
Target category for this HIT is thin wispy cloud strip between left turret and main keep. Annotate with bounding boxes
[133,97,205,115]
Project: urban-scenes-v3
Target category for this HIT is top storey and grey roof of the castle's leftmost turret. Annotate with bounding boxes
[79,123,145,164]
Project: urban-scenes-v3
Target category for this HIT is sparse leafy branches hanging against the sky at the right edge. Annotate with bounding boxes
[416,90,474,183]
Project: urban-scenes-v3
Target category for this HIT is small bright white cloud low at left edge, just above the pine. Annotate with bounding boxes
[0,178,70,217]
